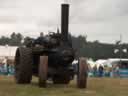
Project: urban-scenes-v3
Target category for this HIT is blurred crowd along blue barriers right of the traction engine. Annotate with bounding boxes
[72,60,124,77]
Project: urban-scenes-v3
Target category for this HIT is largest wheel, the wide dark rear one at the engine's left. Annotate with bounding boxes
[15,47,32,84]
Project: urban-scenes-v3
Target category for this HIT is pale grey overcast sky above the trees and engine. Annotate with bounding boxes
[0,0,128,43]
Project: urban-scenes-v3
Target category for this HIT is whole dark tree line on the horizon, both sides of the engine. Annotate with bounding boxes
[0,32,128,60]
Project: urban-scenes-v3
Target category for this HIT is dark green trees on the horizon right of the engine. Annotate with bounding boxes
[72,36,128,60]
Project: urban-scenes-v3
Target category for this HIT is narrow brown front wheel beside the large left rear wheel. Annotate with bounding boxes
[38,56,48,87]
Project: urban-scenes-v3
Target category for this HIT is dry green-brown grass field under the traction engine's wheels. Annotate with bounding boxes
[0,77,128,96]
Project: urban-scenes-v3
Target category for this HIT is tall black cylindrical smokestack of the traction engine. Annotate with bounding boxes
[61,4,69,41]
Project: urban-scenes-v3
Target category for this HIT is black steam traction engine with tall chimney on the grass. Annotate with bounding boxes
[15,4,87,88]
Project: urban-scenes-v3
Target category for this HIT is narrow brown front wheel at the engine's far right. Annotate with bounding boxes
[77,57,88,88]
